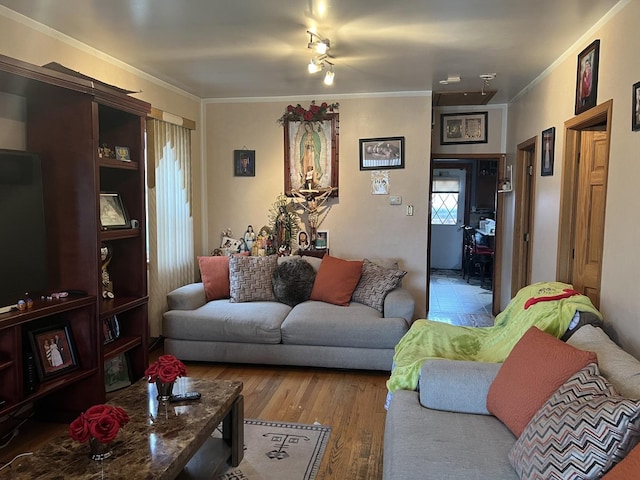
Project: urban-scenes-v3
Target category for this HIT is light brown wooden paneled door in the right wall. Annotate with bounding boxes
[572,131,609,307]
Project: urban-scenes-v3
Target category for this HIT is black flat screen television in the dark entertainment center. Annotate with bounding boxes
[0,149,48,311]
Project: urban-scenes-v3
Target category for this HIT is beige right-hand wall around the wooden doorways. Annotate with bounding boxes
[508,1,640,355]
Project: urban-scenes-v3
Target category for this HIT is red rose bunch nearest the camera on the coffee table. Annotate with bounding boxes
[69,405,129,443]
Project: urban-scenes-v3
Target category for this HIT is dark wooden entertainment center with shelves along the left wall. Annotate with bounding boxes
[0,55,151,418]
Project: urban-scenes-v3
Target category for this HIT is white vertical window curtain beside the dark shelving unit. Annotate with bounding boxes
[147,118,194,337]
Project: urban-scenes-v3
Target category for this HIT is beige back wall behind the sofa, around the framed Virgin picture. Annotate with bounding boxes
[202,96,431,316]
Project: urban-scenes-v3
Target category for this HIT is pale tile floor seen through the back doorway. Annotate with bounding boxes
[427,269,494,327]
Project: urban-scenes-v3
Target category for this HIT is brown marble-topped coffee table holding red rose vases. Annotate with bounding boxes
[9,377,244,480]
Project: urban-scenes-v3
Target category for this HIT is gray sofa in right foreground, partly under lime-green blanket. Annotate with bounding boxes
[383,325,640,480]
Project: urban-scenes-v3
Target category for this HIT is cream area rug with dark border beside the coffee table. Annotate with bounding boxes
[214,419,331,480]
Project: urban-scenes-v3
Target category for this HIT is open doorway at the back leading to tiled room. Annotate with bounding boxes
[426,154,504,318]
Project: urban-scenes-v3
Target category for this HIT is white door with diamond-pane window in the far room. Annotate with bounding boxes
[431,168,466,270]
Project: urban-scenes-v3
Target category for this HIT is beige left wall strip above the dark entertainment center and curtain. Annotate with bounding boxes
[0,11,203,264]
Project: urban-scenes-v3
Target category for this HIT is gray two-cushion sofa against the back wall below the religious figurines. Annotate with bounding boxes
[162,257,414,371]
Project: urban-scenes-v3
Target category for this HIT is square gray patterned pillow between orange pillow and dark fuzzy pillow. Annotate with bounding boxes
[229,255,278,303]
